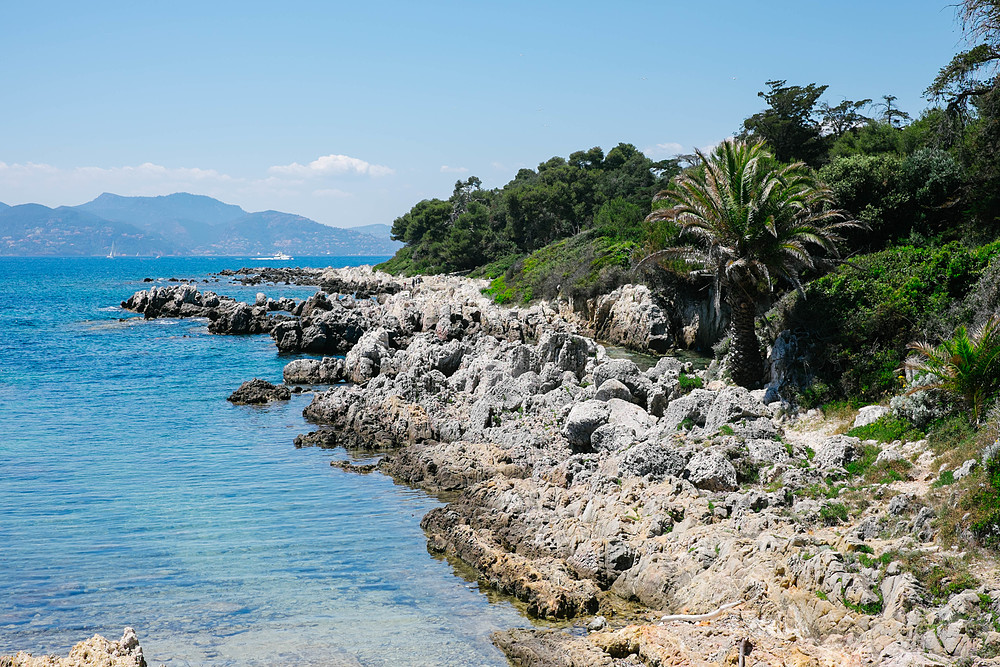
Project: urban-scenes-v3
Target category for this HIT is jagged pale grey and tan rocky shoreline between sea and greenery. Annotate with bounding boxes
[35,267,1000,665]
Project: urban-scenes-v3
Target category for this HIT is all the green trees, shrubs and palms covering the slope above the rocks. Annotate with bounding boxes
[379,0,1000,576]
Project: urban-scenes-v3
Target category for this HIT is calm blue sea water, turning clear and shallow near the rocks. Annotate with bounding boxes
[0,258,525,666]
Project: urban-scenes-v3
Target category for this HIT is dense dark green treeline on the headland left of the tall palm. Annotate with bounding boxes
[385,144,678,274]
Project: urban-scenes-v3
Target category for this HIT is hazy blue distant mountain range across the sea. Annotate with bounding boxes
[0,193,402,257]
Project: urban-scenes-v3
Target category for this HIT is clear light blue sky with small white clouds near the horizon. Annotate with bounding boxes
[0,0,962,227]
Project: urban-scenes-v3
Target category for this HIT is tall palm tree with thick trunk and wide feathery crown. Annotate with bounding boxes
[637,141,858,387]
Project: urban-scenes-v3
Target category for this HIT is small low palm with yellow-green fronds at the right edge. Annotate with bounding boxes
[903,315,1000,424]
